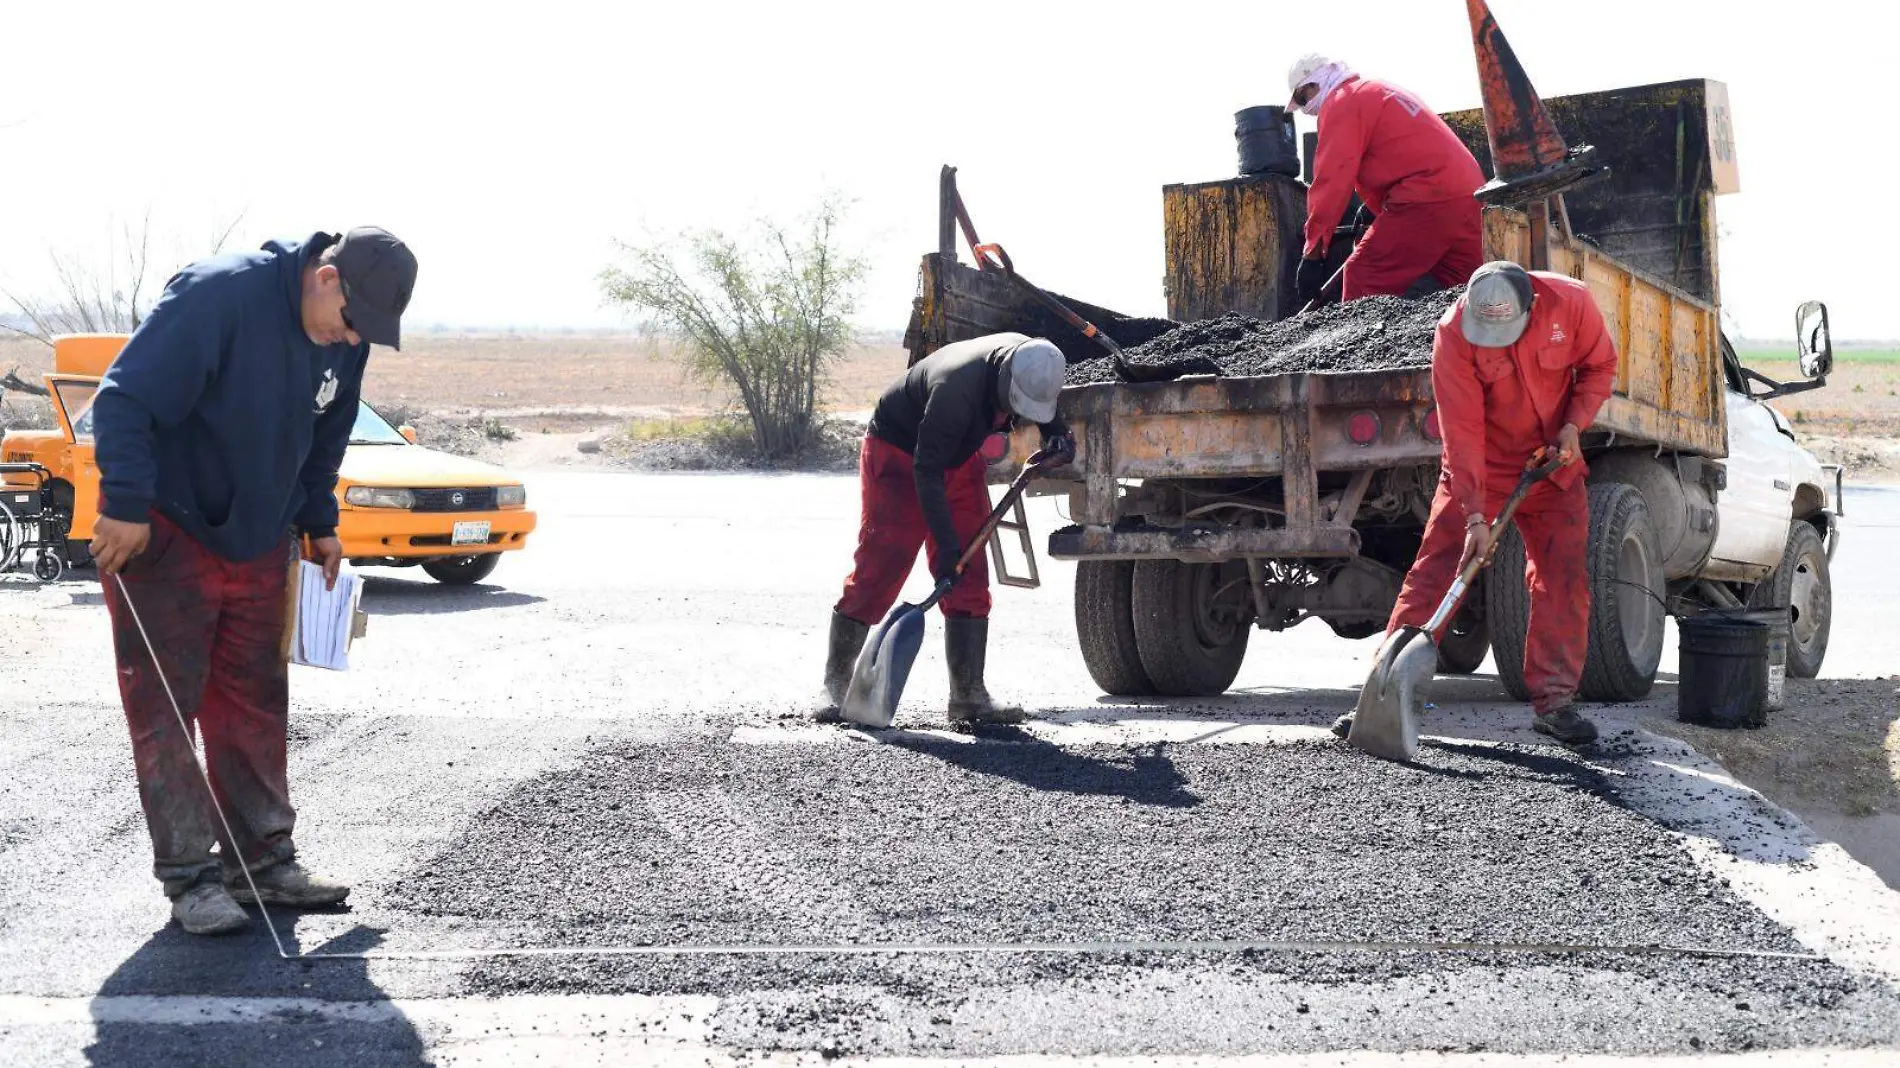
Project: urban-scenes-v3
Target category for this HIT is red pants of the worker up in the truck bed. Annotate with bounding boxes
[1340,198,1484,300]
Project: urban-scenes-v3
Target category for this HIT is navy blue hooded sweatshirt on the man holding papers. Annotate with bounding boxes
[93,234,369,561]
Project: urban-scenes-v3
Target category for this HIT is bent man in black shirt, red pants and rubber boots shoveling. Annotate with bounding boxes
[813,333,1075,726]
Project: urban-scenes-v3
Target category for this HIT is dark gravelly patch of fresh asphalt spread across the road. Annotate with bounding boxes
[401,728,1900,1053]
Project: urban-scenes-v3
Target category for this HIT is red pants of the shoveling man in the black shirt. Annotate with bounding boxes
[836,433,990,625]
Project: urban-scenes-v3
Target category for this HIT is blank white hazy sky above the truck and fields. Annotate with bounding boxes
[0,0,1900,338]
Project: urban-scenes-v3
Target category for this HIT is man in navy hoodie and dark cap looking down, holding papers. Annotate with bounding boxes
[91,226,416,935]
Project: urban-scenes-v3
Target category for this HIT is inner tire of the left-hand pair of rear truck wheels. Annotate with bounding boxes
[1132,561,1254,697]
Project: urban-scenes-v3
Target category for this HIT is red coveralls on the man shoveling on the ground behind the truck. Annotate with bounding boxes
[1387,272,1617,715]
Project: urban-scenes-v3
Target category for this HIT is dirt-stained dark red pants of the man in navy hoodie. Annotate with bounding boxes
[101,513,296,897]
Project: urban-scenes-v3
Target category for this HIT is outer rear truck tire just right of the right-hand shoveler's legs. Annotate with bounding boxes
[1577,483,1666,701]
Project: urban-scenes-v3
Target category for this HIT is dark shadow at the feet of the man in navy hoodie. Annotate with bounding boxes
[86,910,428,1068]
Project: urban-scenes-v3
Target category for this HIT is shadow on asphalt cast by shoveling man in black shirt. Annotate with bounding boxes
[880,726,1201,808]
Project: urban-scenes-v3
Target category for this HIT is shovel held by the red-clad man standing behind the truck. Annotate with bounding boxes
[1345,448,1560,760]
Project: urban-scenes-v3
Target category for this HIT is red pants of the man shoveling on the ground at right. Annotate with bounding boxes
[1385,479,1590,715]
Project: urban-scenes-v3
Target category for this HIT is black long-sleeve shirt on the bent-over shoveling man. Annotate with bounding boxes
[870,333,1064,563]
